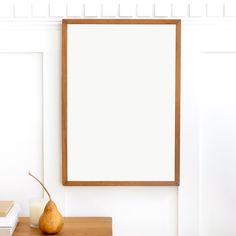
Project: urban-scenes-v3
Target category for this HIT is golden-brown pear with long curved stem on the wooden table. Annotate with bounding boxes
[29,172,64,234]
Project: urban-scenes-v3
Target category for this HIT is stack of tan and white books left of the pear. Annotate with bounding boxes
[0,201,20,236]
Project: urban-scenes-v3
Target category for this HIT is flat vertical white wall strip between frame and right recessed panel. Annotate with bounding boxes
[178,24,202,236]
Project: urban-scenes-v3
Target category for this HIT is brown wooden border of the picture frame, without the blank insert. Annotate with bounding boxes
[61,19,181,186]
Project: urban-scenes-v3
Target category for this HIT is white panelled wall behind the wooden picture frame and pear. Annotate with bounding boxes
[0,1,236,236]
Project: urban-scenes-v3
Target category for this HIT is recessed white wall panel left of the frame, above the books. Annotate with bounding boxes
[0,52,43,215]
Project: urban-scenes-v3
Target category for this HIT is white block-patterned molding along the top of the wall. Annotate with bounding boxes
[0,1,236,21]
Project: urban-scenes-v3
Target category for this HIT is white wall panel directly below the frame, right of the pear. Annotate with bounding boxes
[66,187,177,236]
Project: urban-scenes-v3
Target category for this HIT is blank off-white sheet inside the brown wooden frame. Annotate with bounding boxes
[67,24,176,181]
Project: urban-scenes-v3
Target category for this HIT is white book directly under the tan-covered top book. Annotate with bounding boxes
[0,203,20,228]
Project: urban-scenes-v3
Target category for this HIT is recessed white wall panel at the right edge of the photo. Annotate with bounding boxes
[200,51,236,236]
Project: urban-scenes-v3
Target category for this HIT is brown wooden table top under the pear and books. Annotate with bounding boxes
[13,217,112,236]
